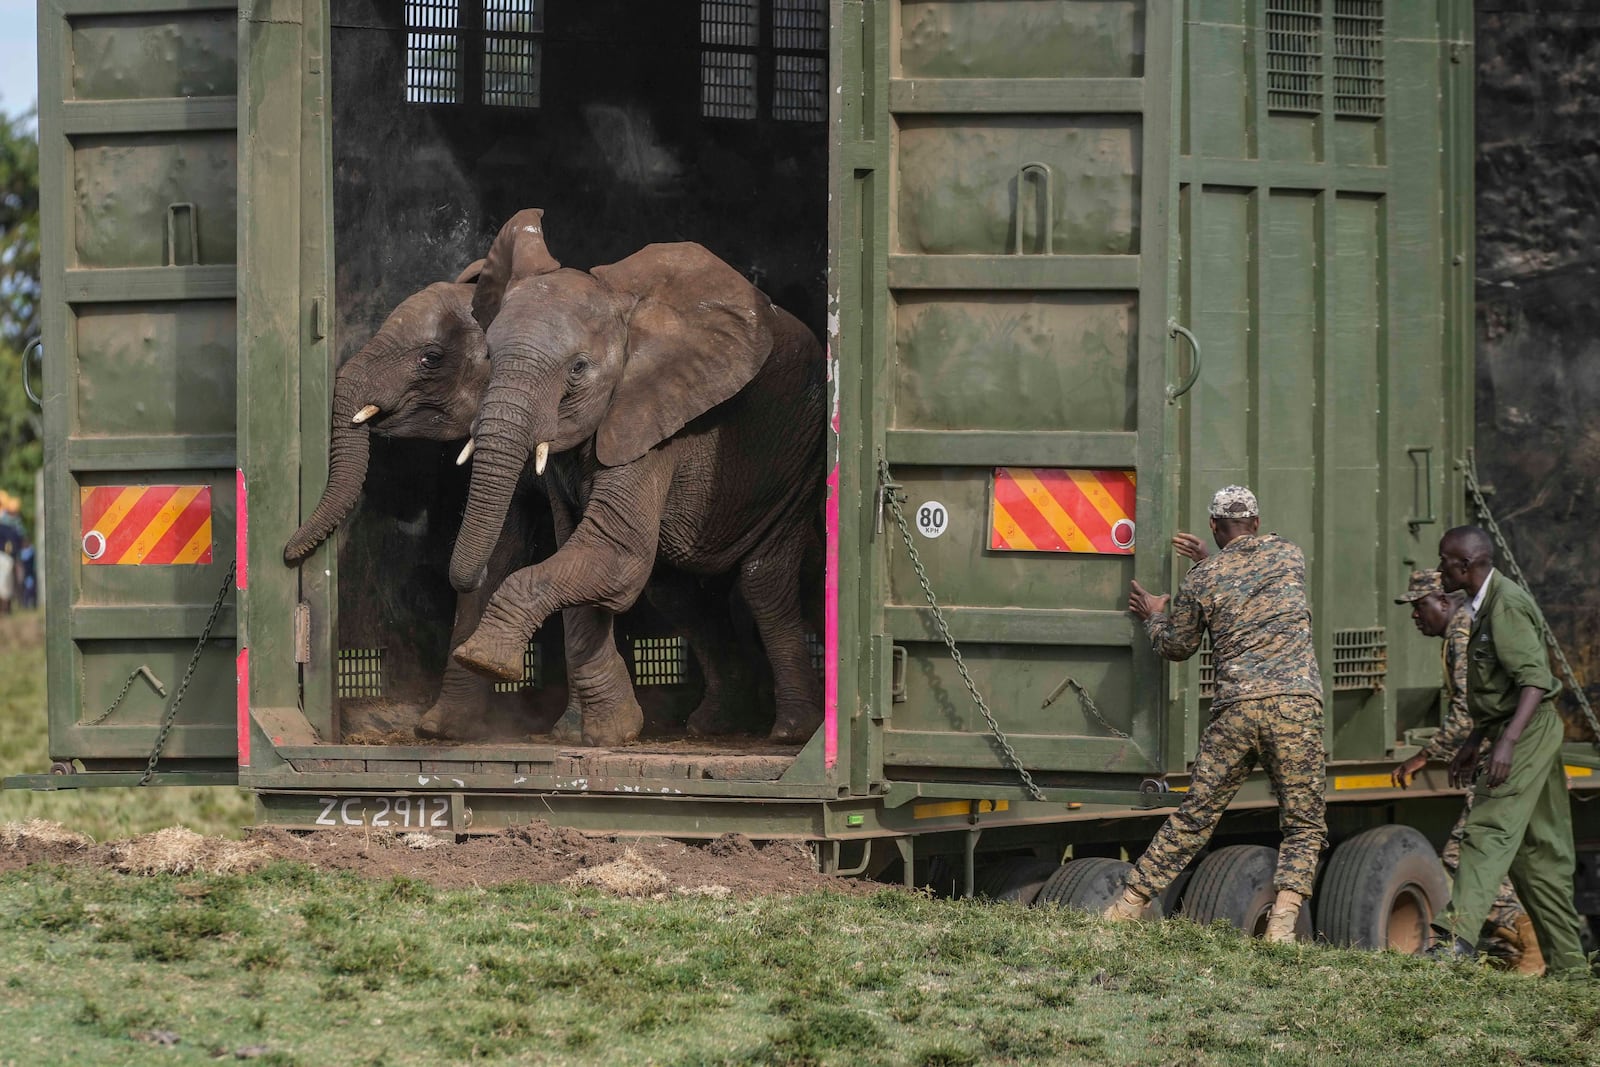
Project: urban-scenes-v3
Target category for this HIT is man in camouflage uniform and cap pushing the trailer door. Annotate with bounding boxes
[1106,485,1328,944]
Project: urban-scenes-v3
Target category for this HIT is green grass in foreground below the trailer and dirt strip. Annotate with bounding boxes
[0,864,1600,1067]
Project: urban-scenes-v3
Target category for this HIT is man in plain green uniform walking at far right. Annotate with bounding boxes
[1429,526,1589,979]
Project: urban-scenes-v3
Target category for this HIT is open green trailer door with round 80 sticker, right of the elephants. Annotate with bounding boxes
[864,0,1189,787]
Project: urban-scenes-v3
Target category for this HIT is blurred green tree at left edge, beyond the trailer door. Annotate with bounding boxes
[0,114,43,533]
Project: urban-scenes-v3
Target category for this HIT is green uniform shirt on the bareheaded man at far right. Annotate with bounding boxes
[1467,571,1562,736]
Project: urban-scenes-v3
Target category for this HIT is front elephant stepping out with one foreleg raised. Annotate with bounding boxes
[450,216,824,745]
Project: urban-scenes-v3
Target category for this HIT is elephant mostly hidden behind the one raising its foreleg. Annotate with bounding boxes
[283,219,755,741]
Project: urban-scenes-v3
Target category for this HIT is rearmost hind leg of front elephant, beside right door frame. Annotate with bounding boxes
[739,525,822,744]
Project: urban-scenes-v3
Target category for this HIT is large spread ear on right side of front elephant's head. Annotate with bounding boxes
[590,243,773,467]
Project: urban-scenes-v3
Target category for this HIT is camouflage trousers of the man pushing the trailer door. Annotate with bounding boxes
[1128,696,1328,897]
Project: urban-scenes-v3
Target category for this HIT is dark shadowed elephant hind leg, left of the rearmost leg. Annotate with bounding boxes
[645,566,755,737]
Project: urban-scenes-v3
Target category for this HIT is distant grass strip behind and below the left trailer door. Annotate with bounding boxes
[0,611,254,838]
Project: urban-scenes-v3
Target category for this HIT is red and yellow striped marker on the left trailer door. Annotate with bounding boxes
[80,485,211,566]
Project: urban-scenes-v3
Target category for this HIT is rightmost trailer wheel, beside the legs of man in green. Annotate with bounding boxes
[1317,825,1450,953]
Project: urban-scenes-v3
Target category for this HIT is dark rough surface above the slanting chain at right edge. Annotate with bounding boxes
[1477,0,1600,726]
